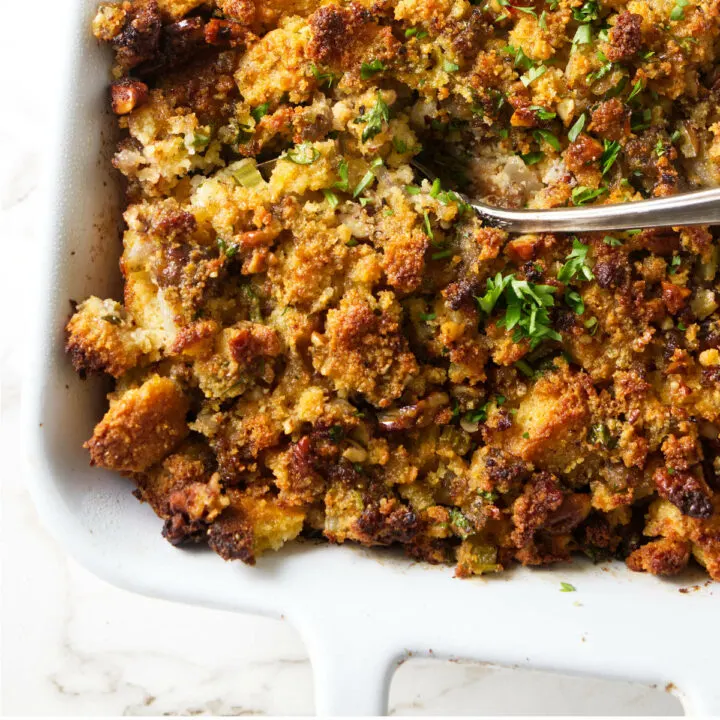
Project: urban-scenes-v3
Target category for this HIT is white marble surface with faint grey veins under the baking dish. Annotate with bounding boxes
[0,0,680,716]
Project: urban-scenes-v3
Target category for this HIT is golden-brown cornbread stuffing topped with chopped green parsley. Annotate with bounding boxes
[67,0,720,580]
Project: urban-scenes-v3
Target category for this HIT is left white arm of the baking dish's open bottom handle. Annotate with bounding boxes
[301,614,402,717]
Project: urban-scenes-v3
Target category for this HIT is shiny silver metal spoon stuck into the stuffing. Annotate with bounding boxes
[258,160,720,233]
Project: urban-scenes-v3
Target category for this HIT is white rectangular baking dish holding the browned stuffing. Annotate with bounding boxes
[25,0,720,715]
